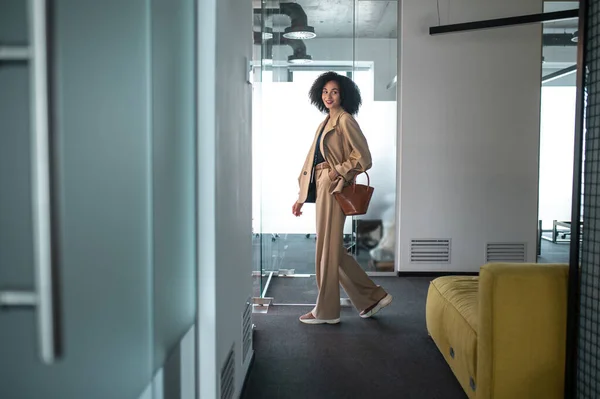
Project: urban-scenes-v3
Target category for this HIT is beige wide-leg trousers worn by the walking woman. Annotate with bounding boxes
[312,169,387,320]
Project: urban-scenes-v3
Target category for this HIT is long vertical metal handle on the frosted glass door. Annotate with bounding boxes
[0,0,61,364]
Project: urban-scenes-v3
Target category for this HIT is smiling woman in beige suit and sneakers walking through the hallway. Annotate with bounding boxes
[292,72,392,324]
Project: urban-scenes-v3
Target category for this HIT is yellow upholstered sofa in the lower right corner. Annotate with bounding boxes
[426,263,568,399]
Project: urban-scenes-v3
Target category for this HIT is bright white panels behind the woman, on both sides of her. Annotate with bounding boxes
[253,80,396,238]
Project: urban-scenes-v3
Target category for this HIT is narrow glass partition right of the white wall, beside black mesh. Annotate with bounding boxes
[537,2,578,263]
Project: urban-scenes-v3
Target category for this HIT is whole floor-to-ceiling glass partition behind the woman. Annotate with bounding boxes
[252,0,398,304]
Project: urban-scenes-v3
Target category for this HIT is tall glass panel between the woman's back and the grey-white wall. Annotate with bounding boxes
[351,1,398,274]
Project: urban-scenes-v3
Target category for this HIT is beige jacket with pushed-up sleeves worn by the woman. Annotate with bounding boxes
[298,111,372,203]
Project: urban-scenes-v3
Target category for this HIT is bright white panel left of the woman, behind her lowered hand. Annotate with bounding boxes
[253,82,324,234]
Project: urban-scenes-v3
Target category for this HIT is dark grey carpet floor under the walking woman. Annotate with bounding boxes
[242,277,466,399]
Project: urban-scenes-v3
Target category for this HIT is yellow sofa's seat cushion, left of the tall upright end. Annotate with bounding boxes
[426,276,478,398]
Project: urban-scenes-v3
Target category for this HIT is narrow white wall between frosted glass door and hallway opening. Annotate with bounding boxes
[198,0,252,399]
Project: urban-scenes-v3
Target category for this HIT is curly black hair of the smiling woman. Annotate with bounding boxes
[308,72,362,115]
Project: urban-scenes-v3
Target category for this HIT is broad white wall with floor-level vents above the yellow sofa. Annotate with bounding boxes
[398,0,542,271]
